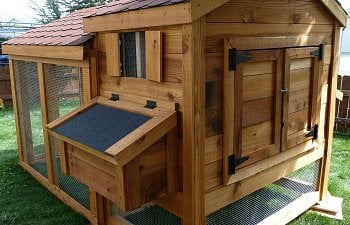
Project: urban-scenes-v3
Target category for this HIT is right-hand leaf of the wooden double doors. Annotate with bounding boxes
[282,47,323,151]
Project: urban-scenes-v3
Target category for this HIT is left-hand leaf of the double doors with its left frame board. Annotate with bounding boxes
[223,39,284,183]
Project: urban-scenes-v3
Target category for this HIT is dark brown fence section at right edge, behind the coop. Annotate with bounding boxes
[335,76,350,132]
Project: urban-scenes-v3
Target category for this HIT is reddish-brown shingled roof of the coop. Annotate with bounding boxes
[3,0,188,46]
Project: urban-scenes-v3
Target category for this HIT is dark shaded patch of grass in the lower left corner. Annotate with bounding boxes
[0,149,88,225]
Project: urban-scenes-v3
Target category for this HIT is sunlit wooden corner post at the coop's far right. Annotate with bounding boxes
[319,21,340,200]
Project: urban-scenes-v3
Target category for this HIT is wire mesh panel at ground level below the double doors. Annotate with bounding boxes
[207,161,320,225]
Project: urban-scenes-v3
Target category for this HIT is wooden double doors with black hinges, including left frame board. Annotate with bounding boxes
[223,41,322,185]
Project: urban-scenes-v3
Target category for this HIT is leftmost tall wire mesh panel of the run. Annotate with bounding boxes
[14,60,47,177]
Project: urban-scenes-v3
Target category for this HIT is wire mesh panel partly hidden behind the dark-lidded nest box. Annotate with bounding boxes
[44,64,90,209]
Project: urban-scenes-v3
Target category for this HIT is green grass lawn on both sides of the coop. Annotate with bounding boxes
[0,108,350,225]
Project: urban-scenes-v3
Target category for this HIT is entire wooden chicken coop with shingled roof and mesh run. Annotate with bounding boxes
[3,0,347,225]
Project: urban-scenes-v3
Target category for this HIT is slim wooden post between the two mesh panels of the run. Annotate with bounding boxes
[37,63,57,184]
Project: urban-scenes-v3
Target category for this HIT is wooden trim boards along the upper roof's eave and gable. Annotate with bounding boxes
[84,0,347,32]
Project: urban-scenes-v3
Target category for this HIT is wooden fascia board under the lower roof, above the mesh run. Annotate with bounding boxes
[2,45,84,61]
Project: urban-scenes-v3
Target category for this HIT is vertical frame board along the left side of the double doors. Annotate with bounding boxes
[223,39,235,184]
